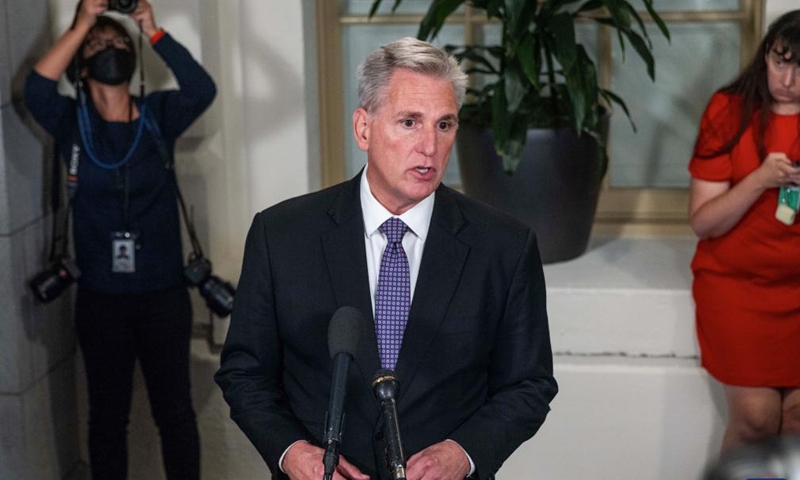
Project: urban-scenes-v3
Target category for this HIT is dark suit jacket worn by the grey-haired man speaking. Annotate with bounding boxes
[215,175,557,478]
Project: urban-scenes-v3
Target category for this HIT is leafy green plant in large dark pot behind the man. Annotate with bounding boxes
[370,0,669,263]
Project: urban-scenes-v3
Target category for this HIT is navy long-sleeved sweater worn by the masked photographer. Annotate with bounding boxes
[25,34,216,294]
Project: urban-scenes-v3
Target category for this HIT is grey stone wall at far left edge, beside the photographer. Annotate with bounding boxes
[0,0,80,480]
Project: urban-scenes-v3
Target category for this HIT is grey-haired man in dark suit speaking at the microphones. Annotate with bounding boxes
[215,38,557,480]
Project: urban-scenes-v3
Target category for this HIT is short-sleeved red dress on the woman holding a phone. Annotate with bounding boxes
[689,93,800,387]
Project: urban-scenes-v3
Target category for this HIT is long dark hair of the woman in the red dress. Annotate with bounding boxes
[694,10,800,160]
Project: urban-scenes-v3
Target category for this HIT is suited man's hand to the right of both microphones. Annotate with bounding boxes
[406,440,469,480]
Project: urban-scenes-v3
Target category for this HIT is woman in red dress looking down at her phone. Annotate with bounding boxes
[689,10,800,451]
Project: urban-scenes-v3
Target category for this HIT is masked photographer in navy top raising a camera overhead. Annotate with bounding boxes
[25,0,216,480]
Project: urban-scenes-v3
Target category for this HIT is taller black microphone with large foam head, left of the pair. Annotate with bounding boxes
[322,307,364,480]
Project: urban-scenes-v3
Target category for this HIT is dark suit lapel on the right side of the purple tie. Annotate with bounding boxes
[396,186,469,397]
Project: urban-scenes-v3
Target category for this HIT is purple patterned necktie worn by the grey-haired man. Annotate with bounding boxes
[375,218,411,370]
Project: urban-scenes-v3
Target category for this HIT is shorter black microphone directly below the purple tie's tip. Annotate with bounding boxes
[372,370,406,480]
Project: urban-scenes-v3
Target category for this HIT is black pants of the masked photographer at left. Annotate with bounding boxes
[75,287,200,480]
